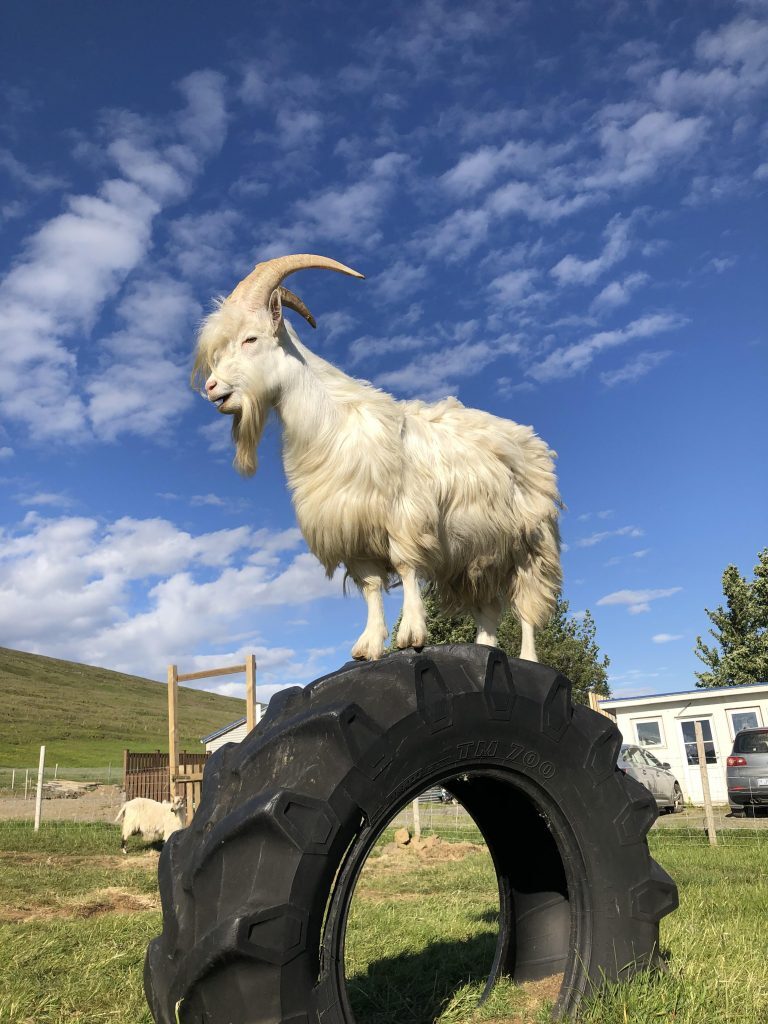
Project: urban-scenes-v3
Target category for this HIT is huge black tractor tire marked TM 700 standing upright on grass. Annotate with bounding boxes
[144,645,678,1024]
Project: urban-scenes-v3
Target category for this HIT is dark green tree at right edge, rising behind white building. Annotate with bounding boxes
[695,548,768,687]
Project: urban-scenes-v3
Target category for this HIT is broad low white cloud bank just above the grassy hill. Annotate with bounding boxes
[0,512,341,676]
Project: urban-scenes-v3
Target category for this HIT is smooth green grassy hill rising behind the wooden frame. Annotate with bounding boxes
[0,647,246,774]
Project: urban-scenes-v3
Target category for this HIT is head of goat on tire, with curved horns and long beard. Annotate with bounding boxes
[193,253,362,475]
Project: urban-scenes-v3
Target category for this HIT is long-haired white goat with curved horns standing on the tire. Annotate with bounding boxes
[193,254,561,660]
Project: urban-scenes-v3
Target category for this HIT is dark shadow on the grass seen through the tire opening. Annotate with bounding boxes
[347,929,498,1024]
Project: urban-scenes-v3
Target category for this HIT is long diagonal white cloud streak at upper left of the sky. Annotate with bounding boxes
[0,72,226,439]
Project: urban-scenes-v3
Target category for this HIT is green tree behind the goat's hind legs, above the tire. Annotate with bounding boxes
[390,592,610,703]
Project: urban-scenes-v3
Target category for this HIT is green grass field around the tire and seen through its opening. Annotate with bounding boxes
[0,823,768,1024]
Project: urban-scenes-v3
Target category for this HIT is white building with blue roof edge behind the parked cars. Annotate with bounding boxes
[598,683,768,804]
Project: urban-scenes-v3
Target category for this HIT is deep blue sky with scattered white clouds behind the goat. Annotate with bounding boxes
[0,0,768,699]
